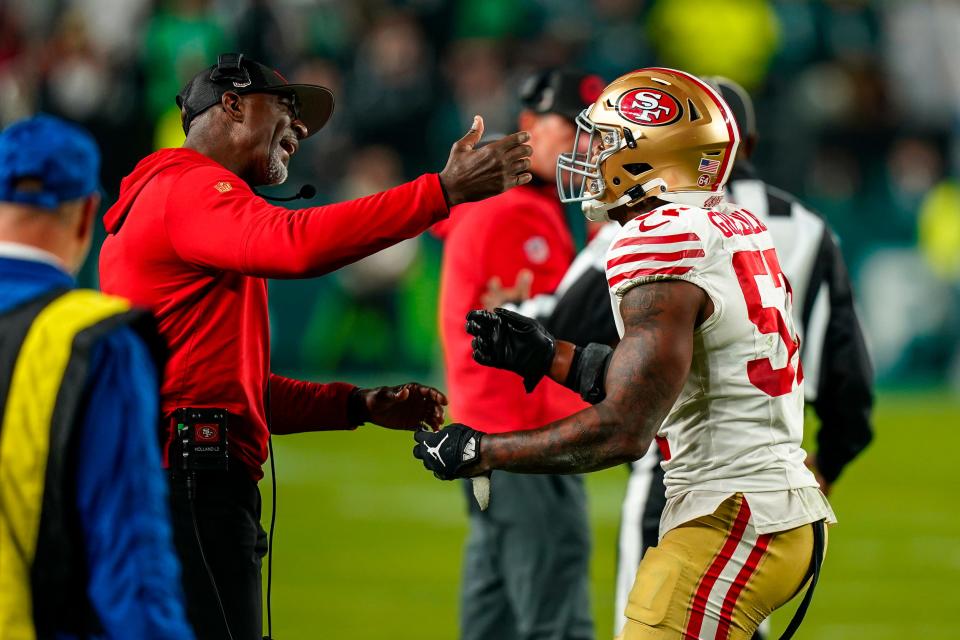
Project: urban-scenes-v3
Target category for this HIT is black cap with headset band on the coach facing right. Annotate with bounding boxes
[177,53,333,137]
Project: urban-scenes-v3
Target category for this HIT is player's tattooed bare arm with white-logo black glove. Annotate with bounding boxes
[414,281,712,479]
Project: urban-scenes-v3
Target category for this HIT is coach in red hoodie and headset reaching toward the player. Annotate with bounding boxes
[100,54,531,640]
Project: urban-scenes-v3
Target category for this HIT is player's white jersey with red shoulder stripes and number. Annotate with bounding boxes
[606,204,832,502]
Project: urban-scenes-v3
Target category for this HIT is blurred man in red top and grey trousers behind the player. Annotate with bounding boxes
[435,69,605,640]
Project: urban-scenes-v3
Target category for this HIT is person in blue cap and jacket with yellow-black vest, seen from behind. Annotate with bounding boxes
[0,115,194,640]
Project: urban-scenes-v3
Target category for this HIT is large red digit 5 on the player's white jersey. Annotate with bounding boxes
[733,249,803,396]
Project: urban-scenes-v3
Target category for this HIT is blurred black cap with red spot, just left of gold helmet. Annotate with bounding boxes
[520,69,607,122]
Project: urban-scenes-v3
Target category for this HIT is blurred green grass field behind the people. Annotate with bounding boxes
[261,393,960,640]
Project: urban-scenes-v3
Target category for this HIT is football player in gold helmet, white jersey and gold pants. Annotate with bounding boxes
[414,68,835,640]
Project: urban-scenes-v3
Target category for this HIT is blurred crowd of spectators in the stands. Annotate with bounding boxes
[0,0,960,388]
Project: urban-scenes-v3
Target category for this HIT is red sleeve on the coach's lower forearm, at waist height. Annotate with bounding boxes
[270,373,358,434]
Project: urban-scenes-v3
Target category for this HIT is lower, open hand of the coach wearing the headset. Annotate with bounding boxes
[350,382,447,431]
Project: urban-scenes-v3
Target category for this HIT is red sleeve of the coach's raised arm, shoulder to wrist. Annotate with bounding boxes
[164,166,448,278]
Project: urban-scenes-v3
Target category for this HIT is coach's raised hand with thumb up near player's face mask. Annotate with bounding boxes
[440,116,533,207]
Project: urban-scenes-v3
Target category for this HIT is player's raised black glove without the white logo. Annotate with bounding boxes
[467,309,557,393]
